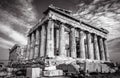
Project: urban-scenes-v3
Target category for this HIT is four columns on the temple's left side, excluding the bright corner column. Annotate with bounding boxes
[26,26,46,59]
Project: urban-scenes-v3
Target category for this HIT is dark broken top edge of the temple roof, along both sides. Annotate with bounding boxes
[28,5,109,35]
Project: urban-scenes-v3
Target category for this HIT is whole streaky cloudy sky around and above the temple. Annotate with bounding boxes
[0,0,120,61]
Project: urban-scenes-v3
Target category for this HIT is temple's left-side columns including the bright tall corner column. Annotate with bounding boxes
[26,19,54,59]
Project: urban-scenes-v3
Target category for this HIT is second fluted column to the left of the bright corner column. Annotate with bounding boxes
[34,29,39,58]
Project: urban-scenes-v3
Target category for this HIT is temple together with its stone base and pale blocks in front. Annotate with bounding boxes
[22,5,110,76]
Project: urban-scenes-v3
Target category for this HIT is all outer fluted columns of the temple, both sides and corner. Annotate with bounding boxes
[26,19,108,60]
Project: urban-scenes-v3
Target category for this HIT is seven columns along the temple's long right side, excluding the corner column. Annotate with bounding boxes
[54,24,108,61]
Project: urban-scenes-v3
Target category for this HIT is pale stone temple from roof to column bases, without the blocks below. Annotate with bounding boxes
[26,6,109,61]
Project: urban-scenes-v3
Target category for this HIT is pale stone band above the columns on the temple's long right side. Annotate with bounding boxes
[50,11,107,38]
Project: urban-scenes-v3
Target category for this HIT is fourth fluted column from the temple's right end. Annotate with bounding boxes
[86,32,94,59]
